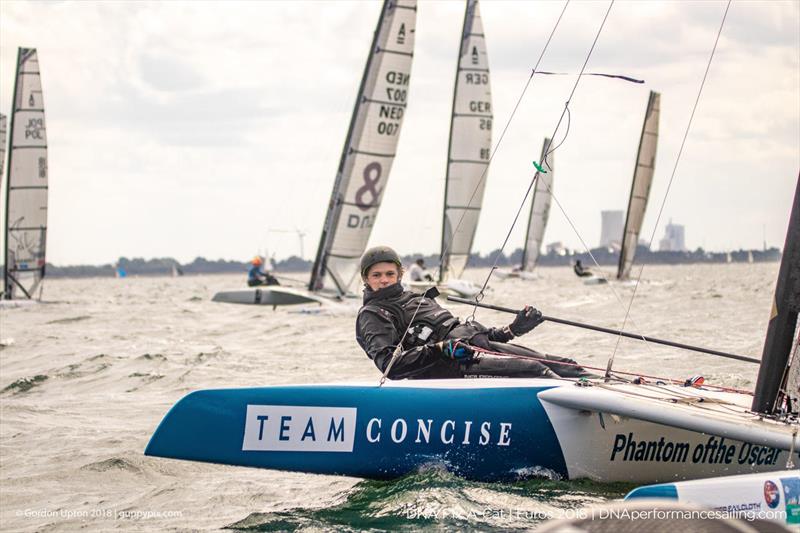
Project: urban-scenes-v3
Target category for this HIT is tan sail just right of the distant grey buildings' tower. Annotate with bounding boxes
[617,91,661,279]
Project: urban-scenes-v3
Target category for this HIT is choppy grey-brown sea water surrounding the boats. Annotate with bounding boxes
[0,263,778,531]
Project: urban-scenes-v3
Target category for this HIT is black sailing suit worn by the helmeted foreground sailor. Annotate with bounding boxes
[356,283,590,379]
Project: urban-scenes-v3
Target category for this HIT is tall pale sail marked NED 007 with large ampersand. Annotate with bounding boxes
[309,0,417,294]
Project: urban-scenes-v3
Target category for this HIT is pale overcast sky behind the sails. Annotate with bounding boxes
[0,0,800,265]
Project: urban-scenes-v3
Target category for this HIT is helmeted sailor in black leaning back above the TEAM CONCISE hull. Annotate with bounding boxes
[356,246,591,379]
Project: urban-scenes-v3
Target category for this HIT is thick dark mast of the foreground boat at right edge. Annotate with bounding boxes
[752,175,800,414]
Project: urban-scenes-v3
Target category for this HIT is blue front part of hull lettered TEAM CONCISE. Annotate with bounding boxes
[145,386,567,480]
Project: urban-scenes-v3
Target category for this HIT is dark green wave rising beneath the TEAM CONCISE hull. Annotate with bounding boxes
[225,465,633,531]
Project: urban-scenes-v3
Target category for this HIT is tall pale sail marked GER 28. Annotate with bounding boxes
[439,0,492,281]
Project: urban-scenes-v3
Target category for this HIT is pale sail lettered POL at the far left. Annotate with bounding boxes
[4,48,47,299]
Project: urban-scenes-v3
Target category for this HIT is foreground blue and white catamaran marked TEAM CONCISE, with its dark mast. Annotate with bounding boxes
[145,176,800,483]
